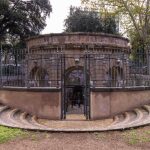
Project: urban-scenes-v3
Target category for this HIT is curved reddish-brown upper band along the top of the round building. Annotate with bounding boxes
[27,33,128,49]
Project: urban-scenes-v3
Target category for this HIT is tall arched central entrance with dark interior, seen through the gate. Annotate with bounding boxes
[65,66,84,114]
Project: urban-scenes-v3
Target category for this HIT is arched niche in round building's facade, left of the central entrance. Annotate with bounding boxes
[29,66,49,87]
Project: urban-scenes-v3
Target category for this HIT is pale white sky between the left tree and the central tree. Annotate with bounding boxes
[42,0,81,34]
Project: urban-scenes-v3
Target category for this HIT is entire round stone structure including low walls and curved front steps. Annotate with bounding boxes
[0,33,150,131]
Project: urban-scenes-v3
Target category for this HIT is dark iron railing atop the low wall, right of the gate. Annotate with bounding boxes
[89,51,150,88]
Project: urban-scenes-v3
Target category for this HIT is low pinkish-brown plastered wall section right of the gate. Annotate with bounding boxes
[90,87,150,119]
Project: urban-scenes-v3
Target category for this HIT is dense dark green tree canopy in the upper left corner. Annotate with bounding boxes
[0,0,52,38]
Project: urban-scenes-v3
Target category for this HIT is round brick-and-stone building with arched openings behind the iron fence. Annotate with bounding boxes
[26,33,130,118]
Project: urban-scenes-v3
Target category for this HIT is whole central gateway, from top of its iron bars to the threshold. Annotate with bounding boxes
[62,56,90,119]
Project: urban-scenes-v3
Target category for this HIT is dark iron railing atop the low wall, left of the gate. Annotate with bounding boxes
[0,46,62,88]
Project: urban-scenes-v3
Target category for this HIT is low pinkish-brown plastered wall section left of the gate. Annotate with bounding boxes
[0,88,61,120]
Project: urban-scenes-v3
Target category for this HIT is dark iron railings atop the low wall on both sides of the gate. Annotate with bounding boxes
[0,45,150,88]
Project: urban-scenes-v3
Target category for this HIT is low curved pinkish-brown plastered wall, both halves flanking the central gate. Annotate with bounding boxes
[0,87,150,120]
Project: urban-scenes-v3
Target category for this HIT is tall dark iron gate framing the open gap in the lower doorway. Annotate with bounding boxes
[61,54,90,119]
